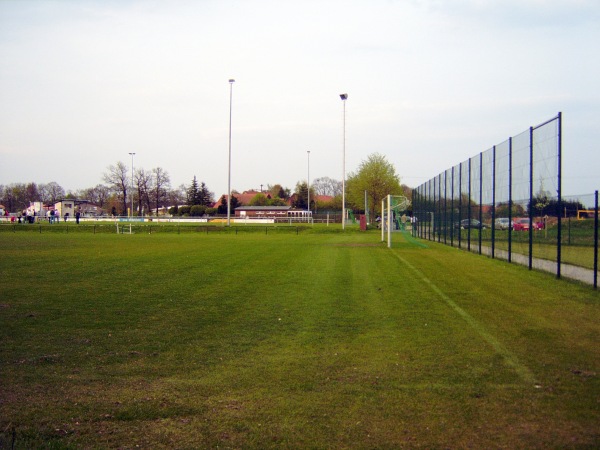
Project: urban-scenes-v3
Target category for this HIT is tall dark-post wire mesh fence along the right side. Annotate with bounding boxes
[412,113,598,287]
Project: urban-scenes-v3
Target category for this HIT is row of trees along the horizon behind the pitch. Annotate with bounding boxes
[0,153,410,217]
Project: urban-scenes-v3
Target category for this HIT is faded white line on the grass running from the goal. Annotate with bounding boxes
[394,252,539,387]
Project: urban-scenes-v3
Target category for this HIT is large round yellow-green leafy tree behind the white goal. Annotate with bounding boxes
[346,153,403,217]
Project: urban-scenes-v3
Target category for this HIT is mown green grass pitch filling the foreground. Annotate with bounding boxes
[0,228,600,449]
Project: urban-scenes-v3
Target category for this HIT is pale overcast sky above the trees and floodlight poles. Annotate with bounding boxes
[0,0,600,197]
